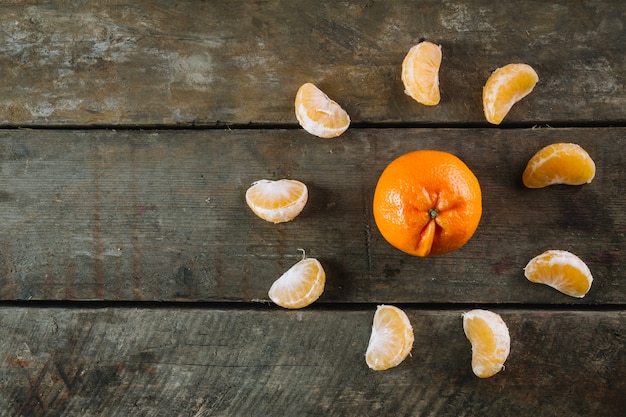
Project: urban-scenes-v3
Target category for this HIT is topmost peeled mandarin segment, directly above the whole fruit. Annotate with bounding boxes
[402,42,442,106]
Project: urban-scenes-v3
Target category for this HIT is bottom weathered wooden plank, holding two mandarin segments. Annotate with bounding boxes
[0,307,626,417]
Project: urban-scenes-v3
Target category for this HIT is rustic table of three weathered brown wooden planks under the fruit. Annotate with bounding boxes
[0,0,626,417]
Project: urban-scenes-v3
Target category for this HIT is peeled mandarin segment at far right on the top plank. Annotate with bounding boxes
[483,64,539,125]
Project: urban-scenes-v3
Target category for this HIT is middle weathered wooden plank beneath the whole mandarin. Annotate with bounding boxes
[0,128,626,304]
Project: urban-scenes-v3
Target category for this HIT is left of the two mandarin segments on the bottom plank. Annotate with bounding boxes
[365,305,414,371]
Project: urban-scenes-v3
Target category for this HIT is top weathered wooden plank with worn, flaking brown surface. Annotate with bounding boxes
[0,0,626,126]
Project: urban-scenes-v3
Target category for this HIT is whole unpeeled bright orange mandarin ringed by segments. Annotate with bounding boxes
[374,150,482,256]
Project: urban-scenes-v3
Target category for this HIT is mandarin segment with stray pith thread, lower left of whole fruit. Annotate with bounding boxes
[268,258,326,309]
